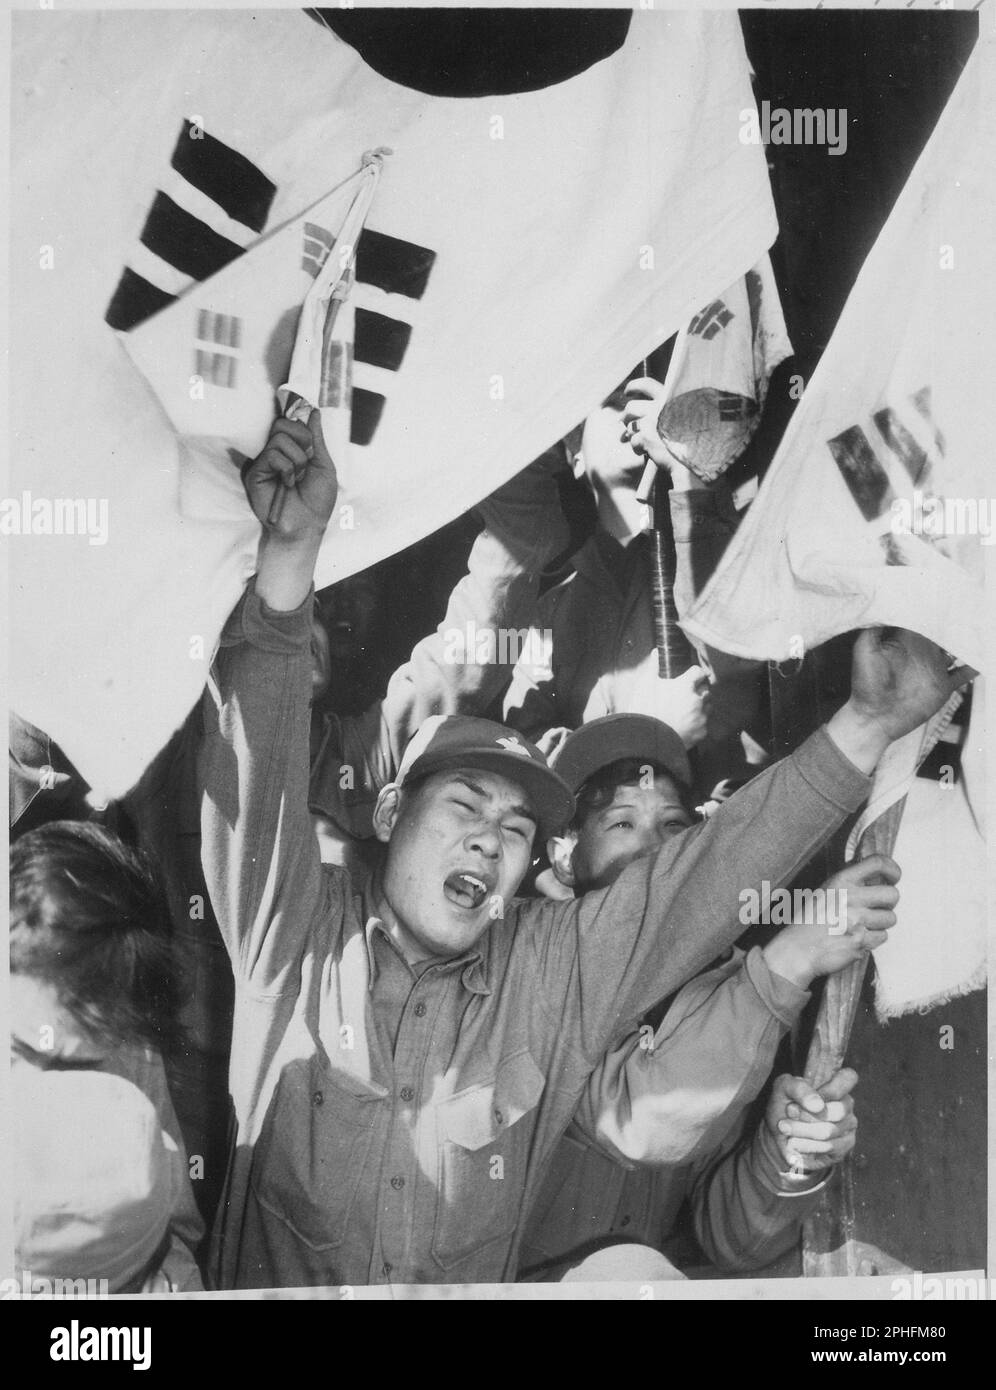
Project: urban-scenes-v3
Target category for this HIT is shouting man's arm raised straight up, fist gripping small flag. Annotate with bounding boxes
[199,411,338,992]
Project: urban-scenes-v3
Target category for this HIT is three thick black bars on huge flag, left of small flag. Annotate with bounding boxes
[104,121,276,329]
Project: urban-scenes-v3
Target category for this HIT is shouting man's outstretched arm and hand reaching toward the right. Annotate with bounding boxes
[524,628,974,1065]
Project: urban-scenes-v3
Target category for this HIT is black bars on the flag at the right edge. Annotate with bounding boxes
[827,386,945,564]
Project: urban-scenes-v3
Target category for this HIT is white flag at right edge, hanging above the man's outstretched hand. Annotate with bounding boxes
[682,43,996,670]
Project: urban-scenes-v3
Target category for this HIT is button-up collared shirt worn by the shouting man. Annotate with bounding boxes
[200,591,868,1287]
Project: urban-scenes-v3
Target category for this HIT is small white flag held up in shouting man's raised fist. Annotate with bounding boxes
[122,152,388,525]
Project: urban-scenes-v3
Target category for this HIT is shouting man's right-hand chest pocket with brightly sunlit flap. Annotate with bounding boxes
[432,1049,546,1269]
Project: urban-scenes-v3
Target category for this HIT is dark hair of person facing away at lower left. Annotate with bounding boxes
[10,820,181,1051]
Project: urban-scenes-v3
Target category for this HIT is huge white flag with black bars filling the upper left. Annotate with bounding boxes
[7,10,777,795]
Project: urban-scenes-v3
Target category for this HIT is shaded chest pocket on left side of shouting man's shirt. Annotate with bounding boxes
[253,1056,388,1251]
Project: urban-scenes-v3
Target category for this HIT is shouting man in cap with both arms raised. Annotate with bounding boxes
[200,411,965,1287]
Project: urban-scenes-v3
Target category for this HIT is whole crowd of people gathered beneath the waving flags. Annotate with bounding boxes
[11,366,958,1293]
